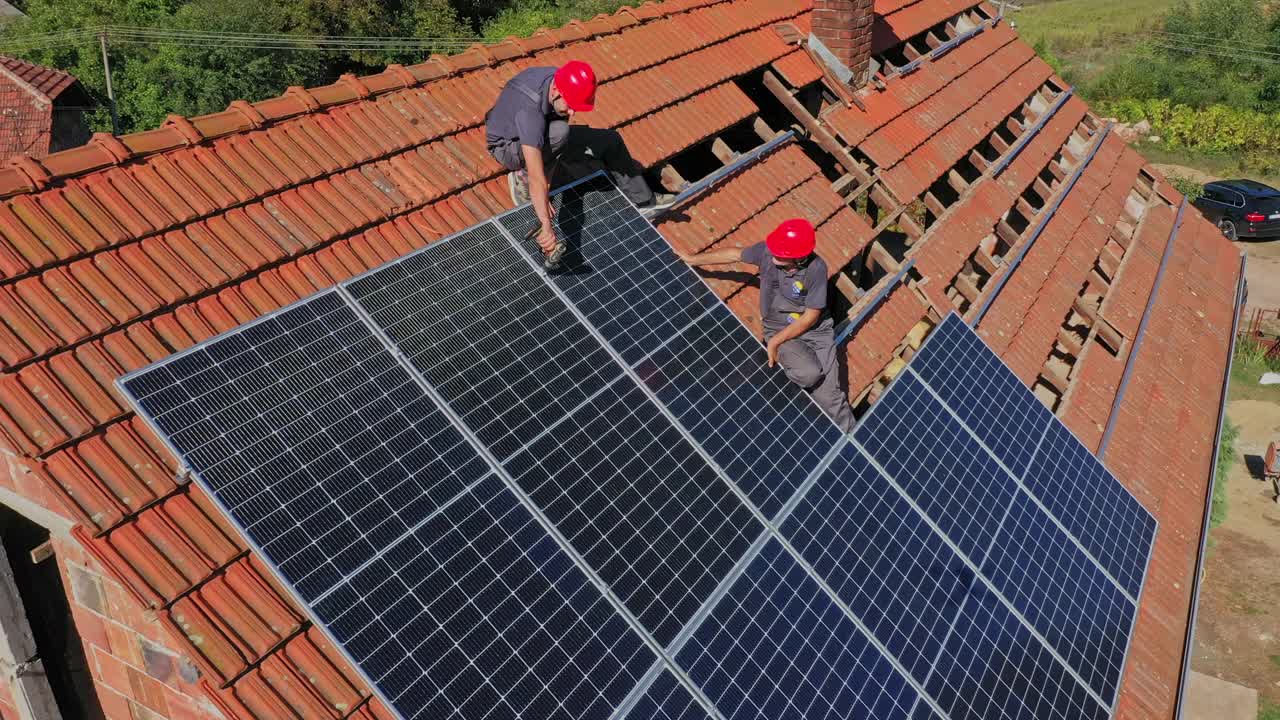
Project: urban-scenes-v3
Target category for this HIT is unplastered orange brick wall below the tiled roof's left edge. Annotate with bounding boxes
[0,450,223,720]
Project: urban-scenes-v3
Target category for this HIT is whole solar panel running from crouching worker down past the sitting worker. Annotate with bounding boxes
[502,176,841,518]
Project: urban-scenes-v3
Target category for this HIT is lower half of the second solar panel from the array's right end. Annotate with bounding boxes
[982,493,1138,703]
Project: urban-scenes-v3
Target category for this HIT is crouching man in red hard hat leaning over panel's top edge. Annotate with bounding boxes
[485,60,671,268]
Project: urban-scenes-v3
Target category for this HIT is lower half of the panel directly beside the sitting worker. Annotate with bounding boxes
[636,305,842,518]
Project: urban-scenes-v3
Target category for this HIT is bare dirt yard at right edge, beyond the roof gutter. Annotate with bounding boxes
[1192,400,1280,703]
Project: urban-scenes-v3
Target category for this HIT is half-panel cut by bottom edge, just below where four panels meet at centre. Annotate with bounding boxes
[676,541,916,720]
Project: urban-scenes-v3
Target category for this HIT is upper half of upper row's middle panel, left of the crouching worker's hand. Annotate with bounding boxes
[346,223,622,459]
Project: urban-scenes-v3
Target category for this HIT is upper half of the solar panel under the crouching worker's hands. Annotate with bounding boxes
[500,176,719,365]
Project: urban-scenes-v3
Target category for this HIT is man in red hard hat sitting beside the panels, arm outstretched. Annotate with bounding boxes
[681,218,854,432]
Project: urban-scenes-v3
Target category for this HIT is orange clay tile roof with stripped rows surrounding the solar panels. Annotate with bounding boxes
[0,0,1238,719]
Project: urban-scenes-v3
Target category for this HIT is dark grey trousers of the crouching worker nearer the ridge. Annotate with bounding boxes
[489,120,653,208]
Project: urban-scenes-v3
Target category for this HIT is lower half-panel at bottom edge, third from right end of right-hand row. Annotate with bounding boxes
[925,585,1110,720]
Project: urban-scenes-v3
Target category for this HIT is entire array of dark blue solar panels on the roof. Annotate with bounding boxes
[120,176,1156,720]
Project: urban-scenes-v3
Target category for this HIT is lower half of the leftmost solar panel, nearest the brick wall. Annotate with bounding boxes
[307,477,655,720]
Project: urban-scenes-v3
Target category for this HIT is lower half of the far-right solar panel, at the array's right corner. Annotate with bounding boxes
[1023,421,1156,598]
